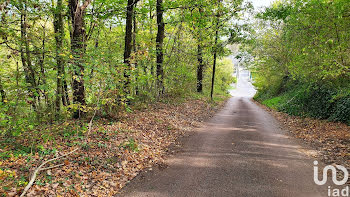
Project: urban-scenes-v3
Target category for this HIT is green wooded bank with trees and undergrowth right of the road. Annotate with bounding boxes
[246,0,350,124]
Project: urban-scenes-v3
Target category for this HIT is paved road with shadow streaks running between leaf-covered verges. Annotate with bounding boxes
[121,72,327,197]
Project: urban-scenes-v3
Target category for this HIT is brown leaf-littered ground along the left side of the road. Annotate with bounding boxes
[0,99,224,196]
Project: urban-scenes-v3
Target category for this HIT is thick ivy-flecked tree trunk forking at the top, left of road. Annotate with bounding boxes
[69,0,91,118]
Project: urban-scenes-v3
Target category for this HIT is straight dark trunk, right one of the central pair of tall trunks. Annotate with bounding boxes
[156,0,165,95]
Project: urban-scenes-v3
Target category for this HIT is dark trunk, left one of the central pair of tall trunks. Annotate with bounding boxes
[124,0,135,95]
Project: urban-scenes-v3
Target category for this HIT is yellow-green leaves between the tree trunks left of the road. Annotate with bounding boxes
[0,0,248,143]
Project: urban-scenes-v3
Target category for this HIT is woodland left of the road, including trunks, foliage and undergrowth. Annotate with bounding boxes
[0,0,243,195]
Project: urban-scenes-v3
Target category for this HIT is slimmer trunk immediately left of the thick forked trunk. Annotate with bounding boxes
[54,0,64,114]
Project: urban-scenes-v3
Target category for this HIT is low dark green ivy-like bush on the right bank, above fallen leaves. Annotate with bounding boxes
[255,83,350,124]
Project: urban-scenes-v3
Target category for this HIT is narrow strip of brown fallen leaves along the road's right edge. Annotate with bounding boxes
[256,102,350,169]
